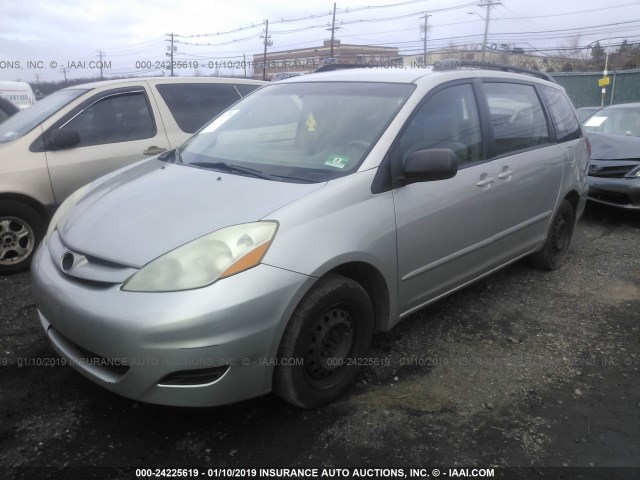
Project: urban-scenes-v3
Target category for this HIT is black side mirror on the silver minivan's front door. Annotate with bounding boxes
[402,148,458,184]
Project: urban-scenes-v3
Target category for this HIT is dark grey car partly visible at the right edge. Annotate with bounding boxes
[584,103,640,210]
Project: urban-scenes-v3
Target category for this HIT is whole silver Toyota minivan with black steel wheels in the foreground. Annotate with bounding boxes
[32,64,589,408]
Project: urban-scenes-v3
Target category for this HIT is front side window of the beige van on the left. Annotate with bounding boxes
[60,92,156,147]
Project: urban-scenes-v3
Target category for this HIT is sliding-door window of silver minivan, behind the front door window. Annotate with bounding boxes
[483,82,549,155]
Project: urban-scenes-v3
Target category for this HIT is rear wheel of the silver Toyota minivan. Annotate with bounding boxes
[529,200,575,270]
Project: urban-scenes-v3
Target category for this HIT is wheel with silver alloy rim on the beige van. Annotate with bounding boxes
[0,200,47,275]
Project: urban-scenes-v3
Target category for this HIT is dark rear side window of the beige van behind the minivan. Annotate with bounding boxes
[157,83,240,133]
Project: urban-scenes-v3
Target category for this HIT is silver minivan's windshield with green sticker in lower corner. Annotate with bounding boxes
[175,82,414,182]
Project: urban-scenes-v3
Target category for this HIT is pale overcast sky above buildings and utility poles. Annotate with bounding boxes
[0,0,640,82]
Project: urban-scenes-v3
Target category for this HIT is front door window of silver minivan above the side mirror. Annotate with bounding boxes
[400,84,482,165]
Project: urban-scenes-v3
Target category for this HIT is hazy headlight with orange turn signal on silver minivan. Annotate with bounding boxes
[122,222,278,292]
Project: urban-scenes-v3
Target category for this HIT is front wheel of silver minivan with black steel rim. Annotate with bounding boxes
[273,274,374,409]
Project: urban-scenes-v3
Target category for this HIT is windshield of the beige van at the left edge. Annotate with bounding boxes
[0,88,87,143]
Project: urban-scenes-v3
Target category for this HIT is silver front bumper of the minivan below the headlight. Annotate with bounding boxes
[31,246,315,406]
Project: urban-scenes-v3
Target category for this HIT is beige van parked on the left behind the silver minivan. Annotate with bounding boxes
[0,78,266,274]
